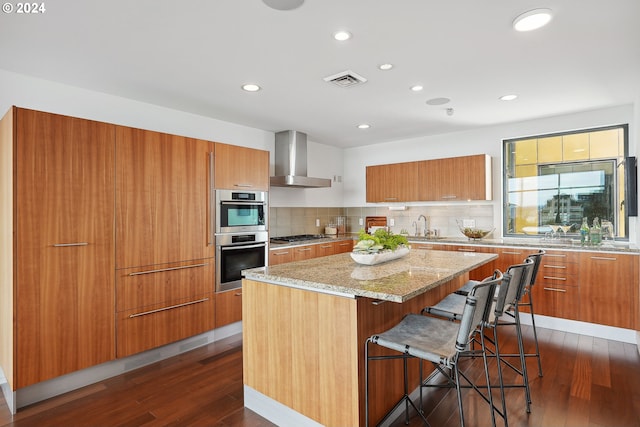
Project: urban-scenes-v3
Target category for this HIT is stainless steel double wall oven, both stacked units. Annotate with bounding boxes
[215,190,269,292]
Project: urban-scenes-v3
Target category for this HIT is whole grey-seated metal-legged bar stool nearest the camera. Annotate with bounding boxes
[365,275,502,427]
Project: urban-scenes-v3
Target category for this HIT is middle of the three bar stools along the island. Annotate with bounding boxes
[422,257,535,426]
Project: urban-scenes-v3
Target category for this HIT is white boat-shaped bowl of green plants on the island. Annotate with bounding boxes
[351,228,409,265]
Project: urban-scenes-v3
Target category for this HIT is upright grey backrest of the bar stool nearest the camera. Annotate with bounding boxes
[456,275,502,351]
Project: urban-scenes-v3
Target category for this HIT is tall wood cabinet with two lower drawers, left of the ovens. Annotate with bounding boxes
[116,126,215,357]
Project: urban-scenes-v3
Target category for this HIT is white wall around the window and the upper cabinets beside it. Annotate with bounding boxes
[344,103,640,242]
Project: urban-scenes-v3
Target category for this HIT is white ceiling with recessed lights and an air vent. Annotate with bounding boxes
[0,0,640,147]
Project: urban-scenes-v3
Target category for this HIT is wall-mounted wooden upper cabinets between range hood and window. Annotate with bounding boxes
[367,154,492,203]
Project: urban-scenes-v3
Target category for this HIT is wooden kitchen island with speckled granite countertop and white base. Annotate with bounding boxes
[242,251,497,426]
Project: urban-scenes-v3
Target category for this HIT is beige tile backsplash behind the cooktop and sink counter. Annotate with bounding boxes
[269,204,494,237]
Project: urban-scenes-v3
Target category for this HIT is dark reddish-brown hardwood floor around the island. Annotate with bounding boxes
[0,327,640,427]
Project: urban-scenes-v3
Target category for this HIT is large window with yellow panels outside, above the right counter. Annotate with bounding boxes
[503,125,628,238]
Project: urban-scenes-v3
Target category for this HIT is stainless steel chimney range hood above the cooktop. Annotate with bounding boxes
[270,130,331,188]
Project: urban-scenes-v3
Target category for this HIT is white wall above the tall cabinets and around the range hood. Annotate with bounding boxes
[0,70,343,207]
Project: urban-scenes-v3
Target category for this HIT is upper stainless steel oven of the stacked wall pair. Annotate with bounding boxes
[216,190,268,233]
